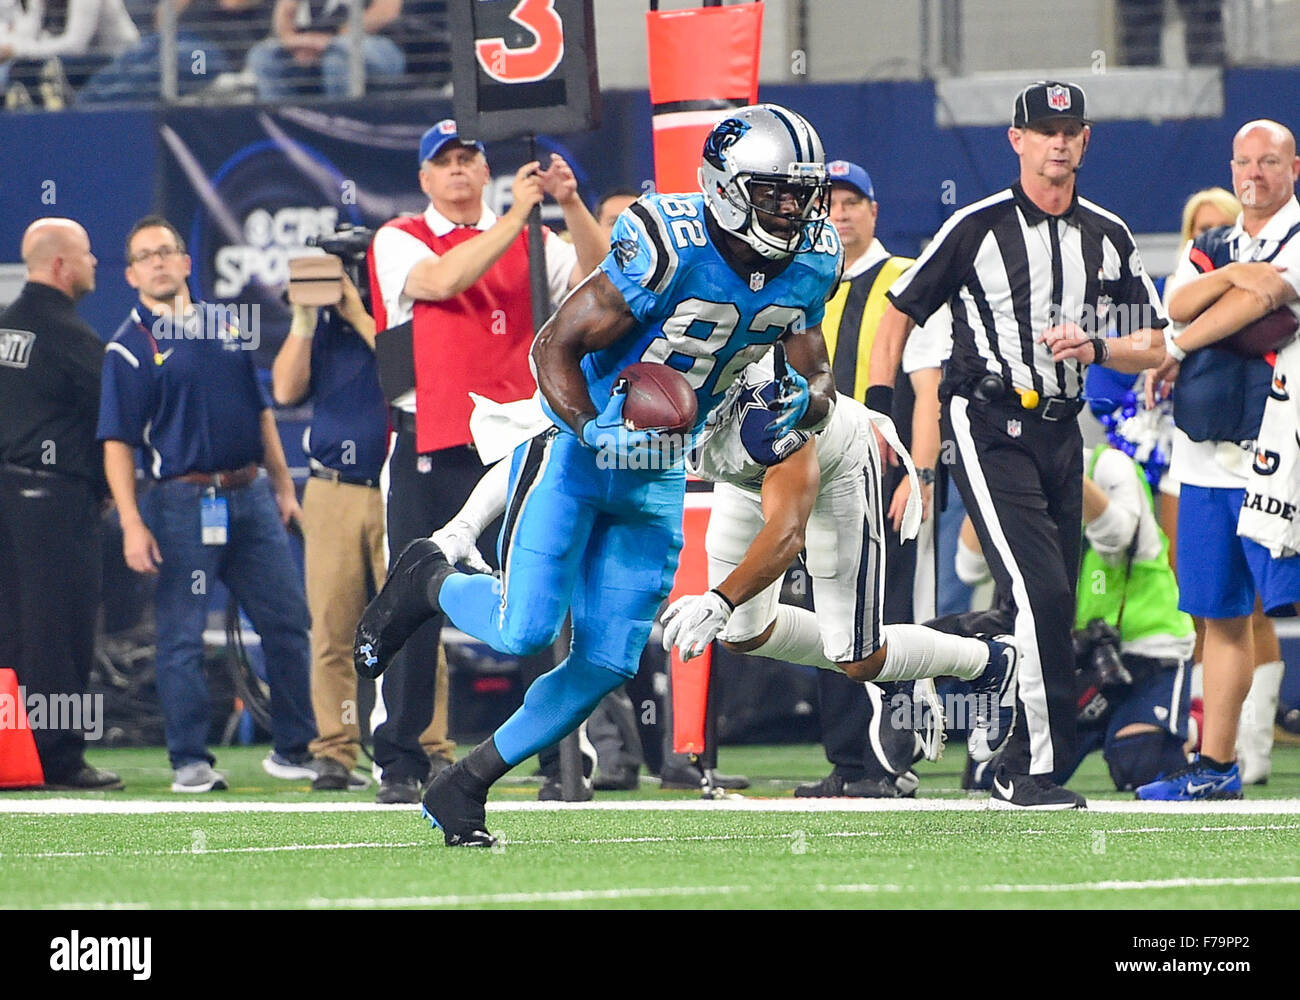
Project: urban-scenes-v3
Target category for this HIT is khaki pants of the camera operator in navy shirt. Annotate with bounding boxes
[303,477,456,769]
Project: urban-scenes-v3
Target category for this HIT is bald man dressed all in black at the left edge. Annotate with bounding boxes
[0,218,122,791]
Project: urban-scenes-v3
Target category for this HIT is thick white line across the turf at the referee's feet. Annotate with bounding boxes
[0,796,1300,815]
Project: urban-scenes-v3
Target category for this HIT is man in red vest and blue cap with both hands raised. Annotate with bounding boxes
[371,120,608,802]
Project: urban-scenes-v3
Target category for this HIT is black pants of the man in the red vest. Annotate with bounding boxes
[374,430,495,782]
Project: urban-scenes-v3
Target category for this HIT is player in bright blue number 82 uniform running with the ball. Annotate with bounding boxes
[354,104,844,847]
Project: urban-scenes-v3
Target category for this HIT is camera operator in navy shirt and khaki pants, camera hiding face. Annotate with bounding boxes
[272,241,387,791]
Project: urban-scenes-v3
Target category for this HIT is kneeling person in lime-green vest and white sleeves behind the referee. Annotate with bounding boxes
[957,445,1196,792]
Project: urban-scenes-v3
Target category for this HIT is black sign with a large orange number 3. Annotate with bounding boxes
[447,0,601,140]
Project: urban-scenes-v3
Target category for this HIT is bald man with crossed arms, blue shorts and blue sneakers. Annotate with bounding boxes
[1138,120,1300,800]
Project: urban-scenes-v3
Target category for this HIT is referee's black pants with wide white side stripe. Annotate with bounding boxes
[941,395,1083,780]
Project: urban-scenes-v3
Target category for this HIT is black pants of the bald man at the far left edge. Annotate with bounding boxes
[0,468,103,783]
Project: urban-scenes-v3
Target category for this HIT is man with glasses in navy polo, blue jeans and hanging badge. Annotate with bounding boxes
[98,216,316,792]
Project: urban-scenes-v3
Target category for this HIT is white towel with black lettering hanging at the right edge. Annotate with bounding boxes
[1236,339,1300,559]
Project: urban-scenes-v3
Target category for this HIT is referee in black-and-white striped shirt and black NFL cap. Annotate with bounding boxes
[867,81,1166,809]
